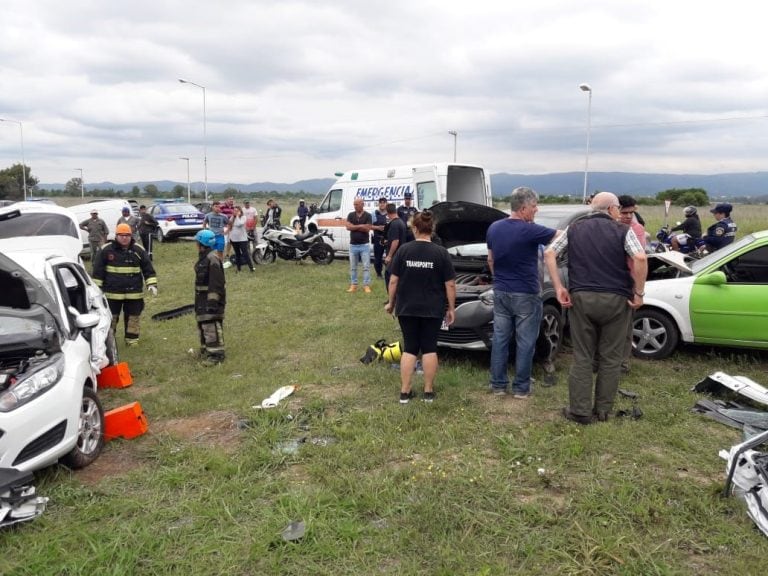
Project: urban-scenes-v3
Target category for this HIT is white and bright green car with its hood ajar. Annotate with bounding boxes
[632,230,768,360]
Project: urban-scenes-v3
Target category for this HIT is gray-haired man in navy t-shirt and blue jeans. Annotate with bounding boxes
[486,187,559,398]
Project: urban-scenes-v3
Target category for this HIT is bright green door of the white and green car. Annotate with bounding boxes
[690,238,768,348]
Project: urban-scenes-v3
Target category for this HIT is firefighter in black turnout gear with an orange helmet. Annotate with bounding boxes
[93,224,157,346]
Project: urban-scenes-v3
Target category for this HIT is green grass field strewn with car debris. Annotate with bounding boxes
[0,201,768,575]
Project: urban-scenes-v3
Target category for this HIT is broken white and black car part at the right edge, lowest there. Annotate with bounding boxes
[719,431,768,536]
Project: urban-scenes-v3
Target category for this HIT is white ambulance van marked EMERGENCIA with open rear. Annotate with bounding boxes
[300,163,493,252]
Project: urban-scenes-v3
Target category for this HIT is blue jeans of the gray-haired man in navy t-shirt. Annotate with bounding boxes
[491,290,543,394]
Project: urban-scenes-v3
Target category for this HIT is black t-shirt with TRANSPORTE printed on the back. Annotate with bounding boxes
[390,241,456,318]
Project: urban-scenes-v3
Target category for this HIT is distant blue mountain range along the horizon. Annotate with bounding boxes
[38,172,768,198]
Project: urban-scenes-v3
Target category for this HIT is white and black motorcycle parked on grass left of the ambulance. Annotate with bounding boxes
[251,222,335,264]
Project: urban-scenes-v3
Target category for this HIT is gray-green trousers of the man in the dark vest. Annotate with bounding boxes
[568,292,632,416]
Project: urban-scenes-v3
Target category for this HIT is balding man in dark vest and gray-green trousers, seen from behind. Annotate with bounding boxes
[544,192,648,424]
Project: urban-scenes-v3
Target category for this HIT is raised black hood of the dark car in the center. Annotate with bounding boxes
[429,202,507,249]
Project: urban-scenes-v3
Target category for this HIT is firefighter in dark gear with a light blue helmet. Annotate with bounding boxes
[195,230,227,366]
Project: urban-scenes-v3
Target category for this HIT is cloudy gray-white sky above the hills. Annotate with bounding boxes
[0,0,768,184]
